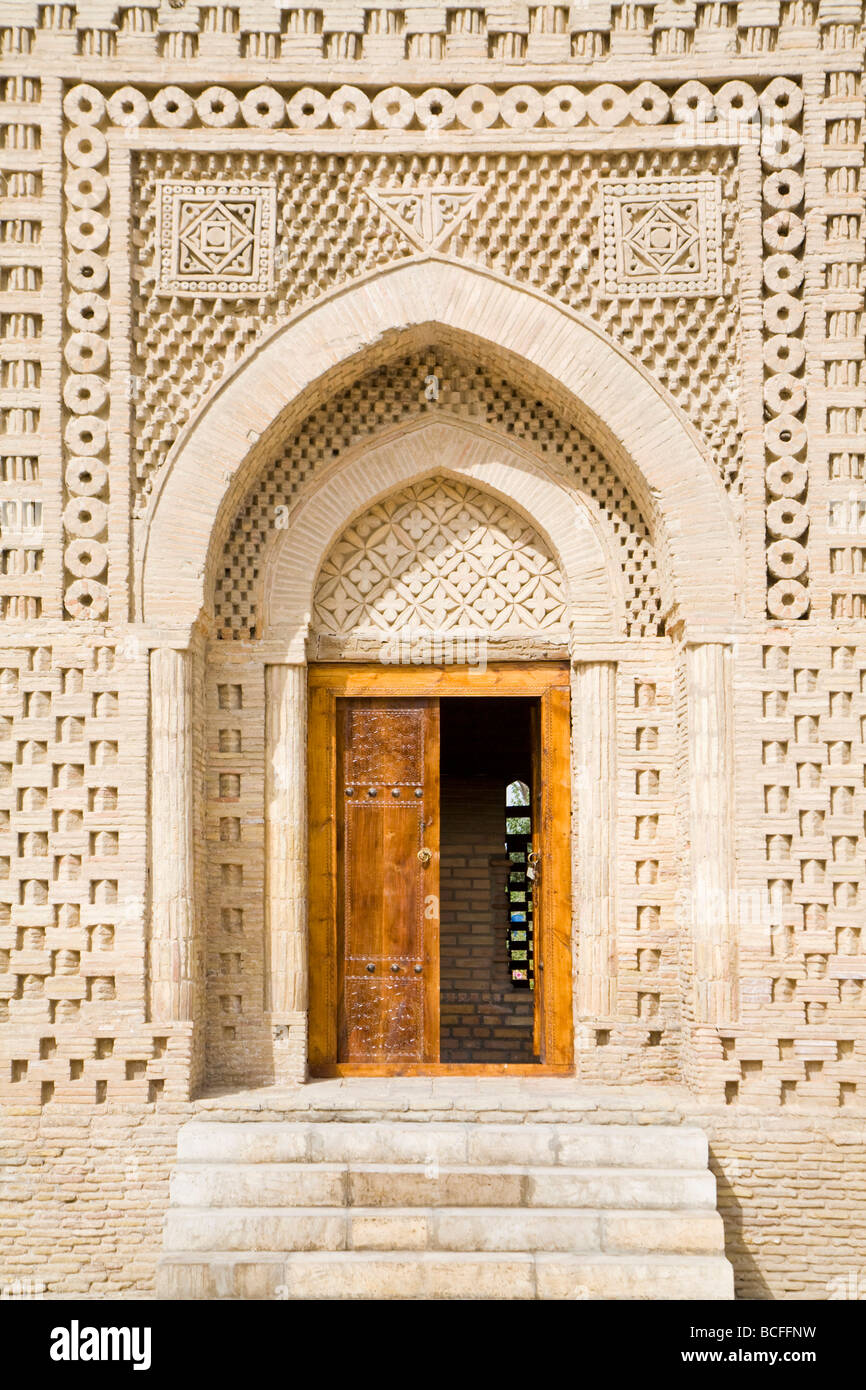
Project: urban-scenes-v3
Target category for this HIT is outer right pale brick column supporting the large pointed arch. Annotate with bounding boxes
[685,642,738,1024]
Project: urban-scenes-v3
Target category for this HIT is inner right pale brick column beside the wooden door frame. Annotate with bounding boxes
[571,662,616,1022]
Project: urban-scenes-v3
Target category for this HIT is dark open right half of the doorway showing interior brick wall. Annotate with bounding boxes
[439,698,538,1065]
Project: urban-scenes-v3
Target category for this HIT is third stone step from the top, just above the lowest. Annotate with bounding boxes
[164,1207,724,1255]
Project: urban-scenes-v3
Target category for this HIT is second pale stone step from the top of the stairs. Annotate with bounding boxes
[171,1162,716,1211]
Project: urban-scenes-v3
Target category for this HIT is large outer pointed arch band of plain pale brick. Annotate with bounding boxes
[138,259,741,628]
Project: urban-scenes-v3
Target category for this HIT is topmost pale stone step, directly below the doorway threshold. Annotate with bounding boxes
[178,1120,708,1169]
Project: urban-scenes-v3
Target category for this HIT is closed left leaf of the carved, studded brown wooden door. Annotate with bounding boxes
[336,699,439,1063]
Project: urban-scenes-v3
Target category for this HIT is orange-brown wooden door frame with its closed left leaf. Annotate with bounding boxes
[307,662,574,1076]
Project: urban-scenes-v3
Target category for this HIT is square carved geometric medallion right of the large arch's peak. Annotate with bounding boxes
[602,174,721,296]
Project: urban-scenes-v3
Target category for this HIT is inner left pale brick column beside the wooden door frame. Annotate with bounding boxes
[264,663,307,1083]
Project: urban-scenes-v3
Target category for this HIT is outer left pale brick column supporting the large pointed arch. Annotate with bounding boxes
[149,648,196,1023]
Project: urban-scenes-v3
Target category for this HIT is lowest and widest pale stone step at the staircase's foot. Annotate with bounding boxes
[157,1251,734,1301]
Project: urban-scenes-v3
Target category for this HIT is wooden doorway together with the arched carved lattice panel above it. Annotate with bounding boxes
[309,467,583,1074]
